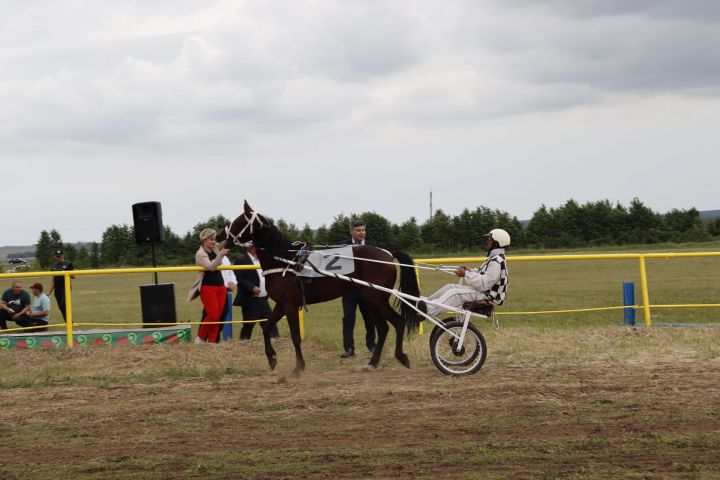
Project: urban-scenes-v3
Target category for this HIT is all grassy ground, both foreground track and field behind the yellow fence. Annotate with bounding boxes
[0,246,720,479]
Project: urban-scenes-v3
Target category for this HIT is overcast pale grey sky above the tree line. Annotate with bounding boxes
[0,0,720,246]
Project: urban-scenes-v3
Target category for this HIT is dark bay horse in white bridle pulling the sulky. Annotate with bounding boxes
[225,201,420,376]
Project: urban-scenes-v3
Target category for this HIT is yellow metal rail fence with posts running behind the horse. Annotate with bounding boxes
[0,252,720,348]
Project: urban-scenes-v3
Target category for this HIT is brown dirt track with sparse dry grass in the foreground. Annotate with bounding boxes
[0,340,720,479]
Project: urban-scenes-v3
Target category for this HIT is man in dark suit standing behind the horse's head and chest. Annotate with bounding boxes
[233,245,280,340]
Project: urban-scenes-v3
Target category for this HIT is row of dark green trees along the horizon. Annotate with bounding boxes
[35,198,720,269]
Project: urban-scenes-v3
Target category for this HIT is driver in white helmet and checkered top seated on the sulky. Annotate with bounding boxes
[427,228,510,317]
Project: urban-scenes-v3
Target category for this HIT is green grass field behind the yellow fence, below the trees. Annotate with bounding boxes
[8,243,720,336]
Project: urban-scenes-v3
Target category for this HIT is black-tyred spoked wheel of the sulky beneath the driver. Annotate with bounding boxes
[430,320,487,376]
